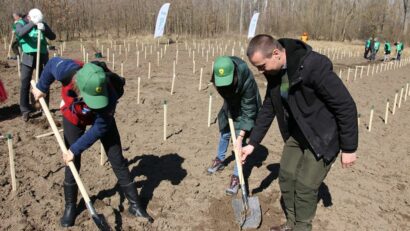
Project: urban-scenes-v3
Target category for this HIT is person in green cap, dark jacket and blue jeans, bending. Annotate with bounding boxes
[207,56,261,195]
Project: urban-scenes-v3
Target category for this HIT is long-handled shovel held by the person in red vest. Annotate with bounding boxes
[31,80,111,231]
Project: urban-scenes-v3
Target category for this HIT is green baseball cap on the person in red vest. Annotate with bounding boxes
[76,63,108,109]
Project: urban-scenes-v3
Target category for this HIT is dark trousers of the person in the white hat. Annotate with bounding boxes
[20,54,50,113]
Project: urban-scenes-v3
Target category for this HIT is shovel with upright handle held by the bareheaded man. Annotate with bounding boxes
[228,118,261,229]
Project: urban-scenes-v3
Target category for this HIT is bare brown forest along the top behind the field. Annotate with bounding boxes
[0,0,410,41]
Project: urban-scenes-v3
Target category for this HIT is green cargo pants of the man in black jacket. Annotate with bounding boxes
[279,137,336,231]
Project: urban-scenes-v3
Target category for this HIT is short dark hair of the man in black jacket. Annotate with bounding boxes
[246,34,283,58]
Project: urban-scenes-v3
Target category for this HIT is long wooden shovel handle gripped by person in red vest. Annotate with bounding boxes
[31,80,91,203]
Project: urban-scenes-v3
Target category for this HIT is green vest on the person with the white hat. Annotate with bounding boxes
[16,19,47,54]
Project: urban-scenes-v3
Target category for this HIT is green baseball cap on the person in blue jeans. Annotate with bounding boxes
[214,56,234,87]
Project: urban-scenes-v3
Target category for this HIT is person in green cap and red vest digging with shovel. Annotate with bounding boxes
[33,57,153,227]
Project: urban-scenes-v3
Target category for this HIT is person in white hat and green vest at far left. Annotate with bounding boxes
[15,8,56,122]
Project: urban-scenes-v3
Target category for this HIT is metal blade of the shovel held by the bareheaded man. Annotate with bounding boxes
[232,197,262,229]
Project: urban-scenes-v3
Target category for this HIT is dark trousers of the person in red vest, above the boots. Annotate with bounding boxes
[63,117,132,185]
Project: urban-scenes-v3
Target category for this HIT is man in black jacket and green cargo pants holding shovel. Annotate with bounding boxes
[242,35,358,231]
